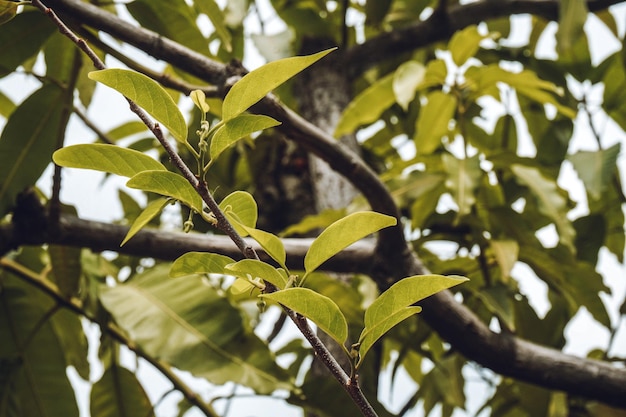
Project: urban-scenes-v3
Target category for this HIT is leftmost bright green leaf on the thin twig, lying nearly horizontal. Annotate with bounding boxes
[52,143,166,177]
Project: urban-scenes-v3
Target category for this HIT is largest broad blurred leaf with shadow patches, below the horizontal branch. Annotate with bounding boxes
[100,265,291,394]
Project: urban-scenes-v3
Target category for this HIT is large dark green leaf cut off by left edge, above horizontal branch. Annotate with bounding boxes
[0,83,66,218]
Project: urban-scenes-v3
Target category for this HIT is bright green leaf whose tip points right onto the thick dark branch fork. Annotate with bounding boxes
[304,211,397,275]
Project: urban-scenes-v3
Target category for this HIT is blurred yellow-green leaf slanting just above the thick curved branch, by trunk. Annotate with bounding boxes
[334,73,396,138]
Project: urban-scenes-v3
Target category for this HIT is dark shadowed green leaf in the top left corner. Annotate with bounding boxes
[0,10,56,77]
